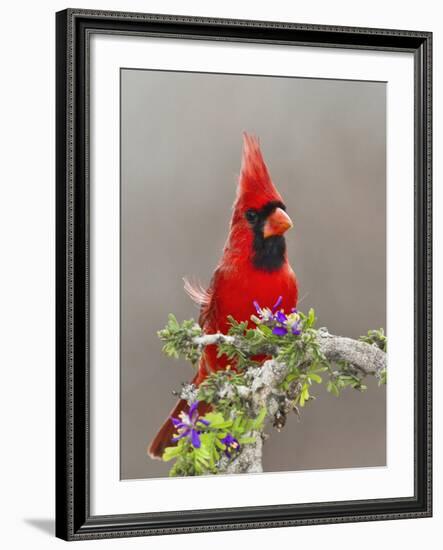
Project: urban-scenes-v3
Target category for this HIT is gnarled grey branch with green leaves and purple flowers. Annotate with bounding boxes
[159,308,386,475]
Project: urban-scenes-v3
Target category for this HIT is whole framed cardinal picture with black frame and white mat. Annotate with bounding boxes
[56,9,432,540]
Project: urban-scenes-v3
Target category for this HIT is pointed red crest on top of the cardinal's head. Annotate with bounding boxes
[236,132,283,208]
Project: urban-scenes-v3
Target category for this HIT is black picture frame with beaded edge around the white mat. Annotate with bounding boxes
[56,9,432,540]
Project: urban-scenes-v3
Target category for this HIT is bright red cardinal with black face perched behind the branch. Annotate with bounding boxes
[148,133,298,458]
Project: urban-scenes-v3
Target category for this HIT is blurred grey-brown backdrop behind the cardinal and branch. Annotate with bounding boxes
[121,69,386,479]
